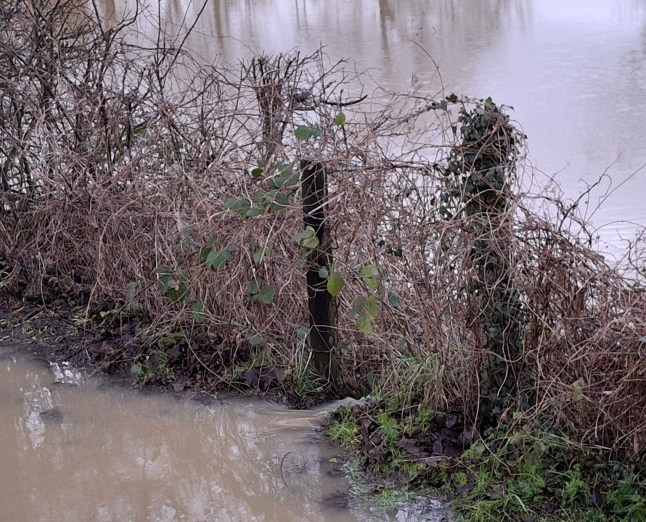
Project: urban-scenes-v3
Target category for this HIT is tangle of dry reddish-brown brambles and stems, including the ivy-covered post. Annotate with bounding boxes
[0,0,646,459]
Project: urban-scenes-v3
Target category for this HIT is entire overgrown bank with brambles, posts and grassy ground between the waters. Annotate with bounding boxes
[0,0,646,520]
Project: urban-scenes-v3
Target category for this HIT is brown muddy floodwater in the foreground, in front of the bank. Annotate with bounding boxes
[0,350,450,522]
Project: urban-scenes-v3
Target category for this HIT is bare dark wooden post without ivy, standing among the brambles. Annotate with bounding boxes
[301,156,337,387]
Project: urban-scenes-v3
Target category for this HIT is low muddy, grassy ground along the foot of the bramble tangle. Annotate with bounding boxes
[0,290,646,522]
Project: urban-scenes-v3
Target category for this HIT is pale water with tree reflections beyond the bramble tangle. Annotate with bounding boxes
[97,0,646,258]
